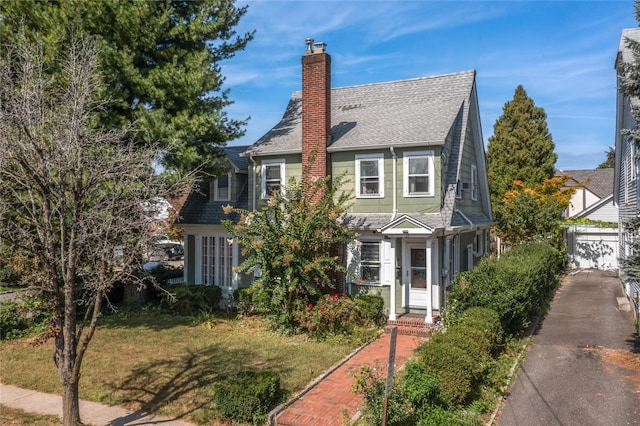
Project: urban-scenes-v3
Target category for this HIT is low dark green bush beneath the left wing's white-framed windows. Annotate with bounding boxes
[163,284,222,316]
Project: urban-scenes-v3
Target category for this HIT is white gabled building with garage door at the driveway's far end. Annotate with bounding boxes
[557,169,619,270]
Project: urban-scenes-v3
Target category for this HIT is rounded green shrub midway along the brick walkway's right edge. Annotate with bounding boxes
[419,342,476,408]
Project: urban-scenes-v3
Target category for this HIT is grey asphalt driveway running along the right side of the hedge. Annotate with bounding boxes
[498,271,640,426]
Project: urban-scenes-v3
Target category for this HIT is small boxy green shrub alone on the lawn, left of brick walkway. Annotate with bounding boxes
[213,370,282,424]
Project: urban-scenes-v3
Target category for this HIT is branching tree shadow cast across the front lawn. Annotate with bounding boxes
[109,344,289,418]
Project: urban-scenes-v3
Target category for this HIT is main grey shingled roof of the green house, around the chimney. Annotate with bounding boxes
[247,70,475,155]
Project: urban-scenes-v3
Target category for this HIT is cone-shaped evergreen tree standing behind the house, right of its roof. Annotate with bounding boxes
[487,85,557,209]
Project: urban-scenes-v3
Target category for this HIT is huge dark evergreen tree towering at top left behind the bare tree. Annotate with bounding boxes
[0,0,253,173]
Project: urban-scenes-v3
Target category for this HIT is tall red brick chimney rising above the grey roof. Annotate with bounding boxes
[302,38,331,185]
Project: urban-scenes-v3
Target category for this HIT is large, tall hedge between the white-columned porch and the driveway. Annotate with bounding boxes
[447,243,562,335]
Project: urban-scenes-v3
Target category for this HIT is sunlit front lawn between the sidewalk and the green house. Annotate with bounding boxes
[0,311,372,424]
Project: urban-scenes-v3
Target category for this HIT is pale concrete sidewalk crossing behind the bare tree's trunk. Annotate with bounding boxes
[0,384,193,426]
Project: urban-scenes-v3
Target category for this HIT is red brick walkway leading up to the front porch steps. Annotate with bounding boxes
[276,334,424,426]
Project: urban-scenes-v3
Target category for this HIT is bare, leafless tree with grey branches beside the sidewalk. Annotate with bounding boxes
[0,40,191,425]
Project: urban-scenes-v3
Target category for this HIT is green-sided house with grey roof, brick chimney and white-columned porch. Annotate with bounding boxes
[181,40,492,323]
